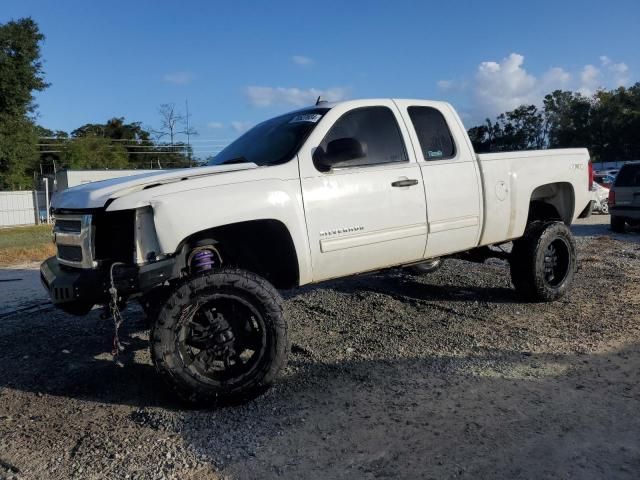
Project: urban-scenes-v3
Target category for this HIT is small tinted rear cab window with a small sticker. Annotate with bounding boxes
[408,107,456,161]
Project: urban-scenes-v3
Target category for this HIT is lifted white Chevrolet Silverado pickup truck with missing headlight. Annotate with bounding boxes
[41,99,592,405]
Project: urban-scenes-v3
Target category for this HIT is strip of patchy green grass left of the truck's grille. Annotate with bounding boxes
[0,224,55,266]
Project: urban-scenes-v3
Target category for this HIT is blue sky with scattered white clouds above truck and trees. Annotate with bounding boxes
[0,0,640,155]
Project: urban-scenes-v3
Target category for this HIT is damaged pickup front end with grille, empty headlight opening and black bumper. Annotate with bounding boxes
[40,207,176,315]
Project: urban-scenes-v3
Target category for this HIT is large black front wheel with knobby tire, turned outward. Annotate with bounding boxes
[150,269,289,406]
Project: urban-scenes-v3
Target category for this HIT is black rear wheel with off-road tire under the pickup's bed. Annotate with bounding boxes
[509,222,576,302]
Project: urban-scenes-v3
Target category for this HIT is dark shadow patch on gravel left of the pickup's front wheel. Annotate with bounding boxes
[0,308,175,407]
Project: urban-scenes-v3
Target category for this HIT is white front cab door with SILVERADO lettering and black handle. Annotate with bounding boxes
[298,100,427,282]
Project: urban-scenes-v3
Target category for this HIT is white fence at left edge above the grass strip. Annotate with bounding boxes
[0,190,47,227]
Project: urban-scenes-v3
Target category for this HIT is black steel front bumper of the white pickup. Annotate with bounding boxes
[40,257,176,313]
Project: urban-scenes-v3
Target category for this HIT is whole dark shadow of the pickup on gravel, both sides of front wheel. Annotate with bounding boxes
[0,262,515,409]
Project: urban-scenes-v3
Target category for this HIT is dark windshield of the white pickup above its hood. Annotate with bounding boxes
[208,108,329,166]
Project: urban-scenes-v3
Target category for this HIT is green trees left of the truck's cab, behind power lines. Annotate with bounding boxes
[0,18,197,190]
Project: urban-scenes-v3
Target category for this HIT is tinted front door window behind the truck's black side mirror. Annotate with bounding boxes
[314,107,408,171]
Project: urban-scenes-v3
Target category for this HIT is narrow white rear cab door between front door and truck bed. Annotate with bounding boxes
[396,100,482,258]
